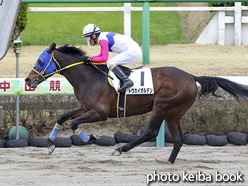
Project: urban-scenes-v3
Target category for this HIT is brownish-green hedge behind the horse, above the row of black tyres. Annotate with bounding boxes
[0,96,248,139]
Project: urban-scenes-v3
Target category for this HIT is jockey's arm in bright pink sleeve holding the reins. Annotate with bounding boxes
[91,40,109,63]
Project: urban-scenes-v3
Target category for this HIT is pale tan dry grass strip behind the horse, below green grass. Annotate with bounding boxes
[0,44,248,78]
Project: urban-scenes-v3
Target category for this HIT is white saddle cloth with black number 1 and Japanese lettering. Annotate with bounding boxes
[108,68,154,95]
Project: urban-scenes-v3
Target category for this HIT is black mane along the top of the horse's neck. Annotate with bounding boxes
[57,44,88,61]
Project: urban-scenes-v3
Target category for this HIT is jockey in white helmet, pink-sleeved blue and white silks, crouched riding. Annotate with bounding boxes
[82,24,142,92]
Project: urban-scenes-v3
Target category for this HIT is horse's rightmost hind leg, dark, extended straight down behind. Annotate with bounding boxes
[166,118,183,164]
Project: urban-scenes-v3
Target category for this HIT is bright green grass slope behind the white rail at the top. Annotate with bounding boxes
[21,3,187,46]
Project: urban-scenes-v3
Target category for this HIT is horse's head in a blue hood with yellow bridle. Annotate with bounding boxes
[25,43,59,88]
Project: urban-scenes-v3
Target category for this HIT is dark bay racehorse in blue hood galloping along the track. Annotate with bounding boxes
[25,43,248,164]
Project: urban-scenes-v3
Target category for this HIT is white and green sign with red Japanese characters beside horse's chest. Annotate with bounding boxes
[0,78,74,96]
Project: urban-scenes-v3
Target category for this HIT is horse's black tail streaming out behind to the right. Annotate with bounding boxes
[194,76,248,101]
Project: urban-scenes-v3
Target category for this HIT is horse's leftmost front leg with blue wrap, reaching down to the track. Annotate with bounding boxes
[48,109,84,154]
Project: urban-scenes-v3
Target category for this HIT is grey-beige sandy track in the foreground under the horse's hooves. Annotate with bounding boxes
[0,145,248,186]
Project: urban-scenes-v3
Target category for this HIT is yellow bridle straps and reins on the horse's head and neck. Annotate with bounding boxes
[32,52,106,81]
